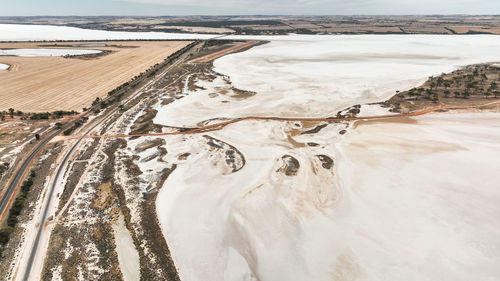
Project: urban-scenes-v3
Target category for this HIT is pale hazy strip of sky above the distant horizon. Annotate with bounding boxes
[0,0,500,16]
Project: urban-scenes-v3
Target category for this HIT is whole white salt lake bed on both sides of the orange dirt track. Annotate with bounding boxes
[150,36,500,281]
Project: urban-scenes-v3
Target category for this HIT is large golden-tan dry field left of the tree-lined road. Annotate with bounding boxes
[0,41,190,112]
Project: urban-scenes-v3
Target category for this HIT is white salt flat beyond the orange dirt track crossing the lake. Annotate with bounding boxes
[155,35,500,126]
